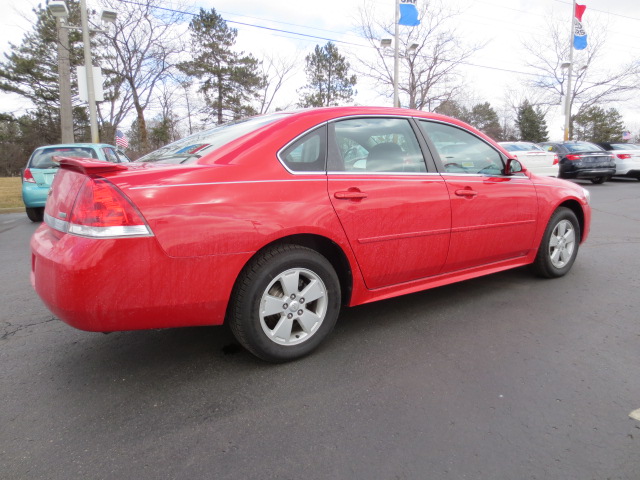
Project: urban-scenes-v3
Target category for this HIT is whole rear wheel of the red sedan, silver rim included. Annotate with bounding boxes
[228,244,341,363]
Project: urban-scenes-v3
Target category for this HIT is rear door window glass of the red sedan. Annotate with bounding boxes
[331,118,427,173]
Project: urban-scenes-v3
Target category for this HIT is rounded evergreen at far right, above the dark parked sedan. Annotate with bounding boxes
[573,105,625,142]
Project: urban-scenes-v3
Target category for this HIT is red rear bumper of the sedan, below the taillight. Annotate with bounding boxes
[31,224,250,332]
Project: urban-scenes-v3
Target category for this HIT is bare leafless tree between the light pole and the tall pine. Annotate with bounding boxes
[100,0,188,150]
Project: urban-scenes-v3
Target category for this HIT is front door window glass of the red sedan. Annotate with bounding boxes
[420,120,504,175]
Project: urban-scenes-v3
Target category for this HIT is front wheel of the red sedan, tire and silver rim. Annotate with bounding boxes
[531,207,581,278]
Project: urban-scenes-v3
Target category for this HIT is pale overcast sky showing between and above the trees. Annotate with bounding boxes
[0,0,640,138]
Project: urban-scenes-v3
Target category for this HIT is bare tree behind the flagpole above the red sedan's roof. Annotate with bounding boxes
[358,0,483,110]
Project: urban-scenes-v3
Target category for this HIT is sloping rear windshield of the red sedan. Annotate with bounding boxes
[136,113,286,163]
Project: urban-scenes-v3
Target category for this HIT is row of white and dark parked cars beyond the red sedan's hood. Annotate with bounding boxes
[500,142,640,183]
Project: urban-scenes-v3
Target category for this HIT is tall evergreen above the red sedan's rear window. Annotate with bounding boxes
[178,8,264,124]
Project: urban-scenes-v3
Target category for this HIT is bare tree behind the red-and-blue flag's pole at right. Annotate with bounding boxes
[523,16,640,135]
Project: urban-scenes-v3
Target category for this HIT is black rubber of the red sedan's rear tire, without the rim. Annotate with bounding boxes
[230,245,341,362]
